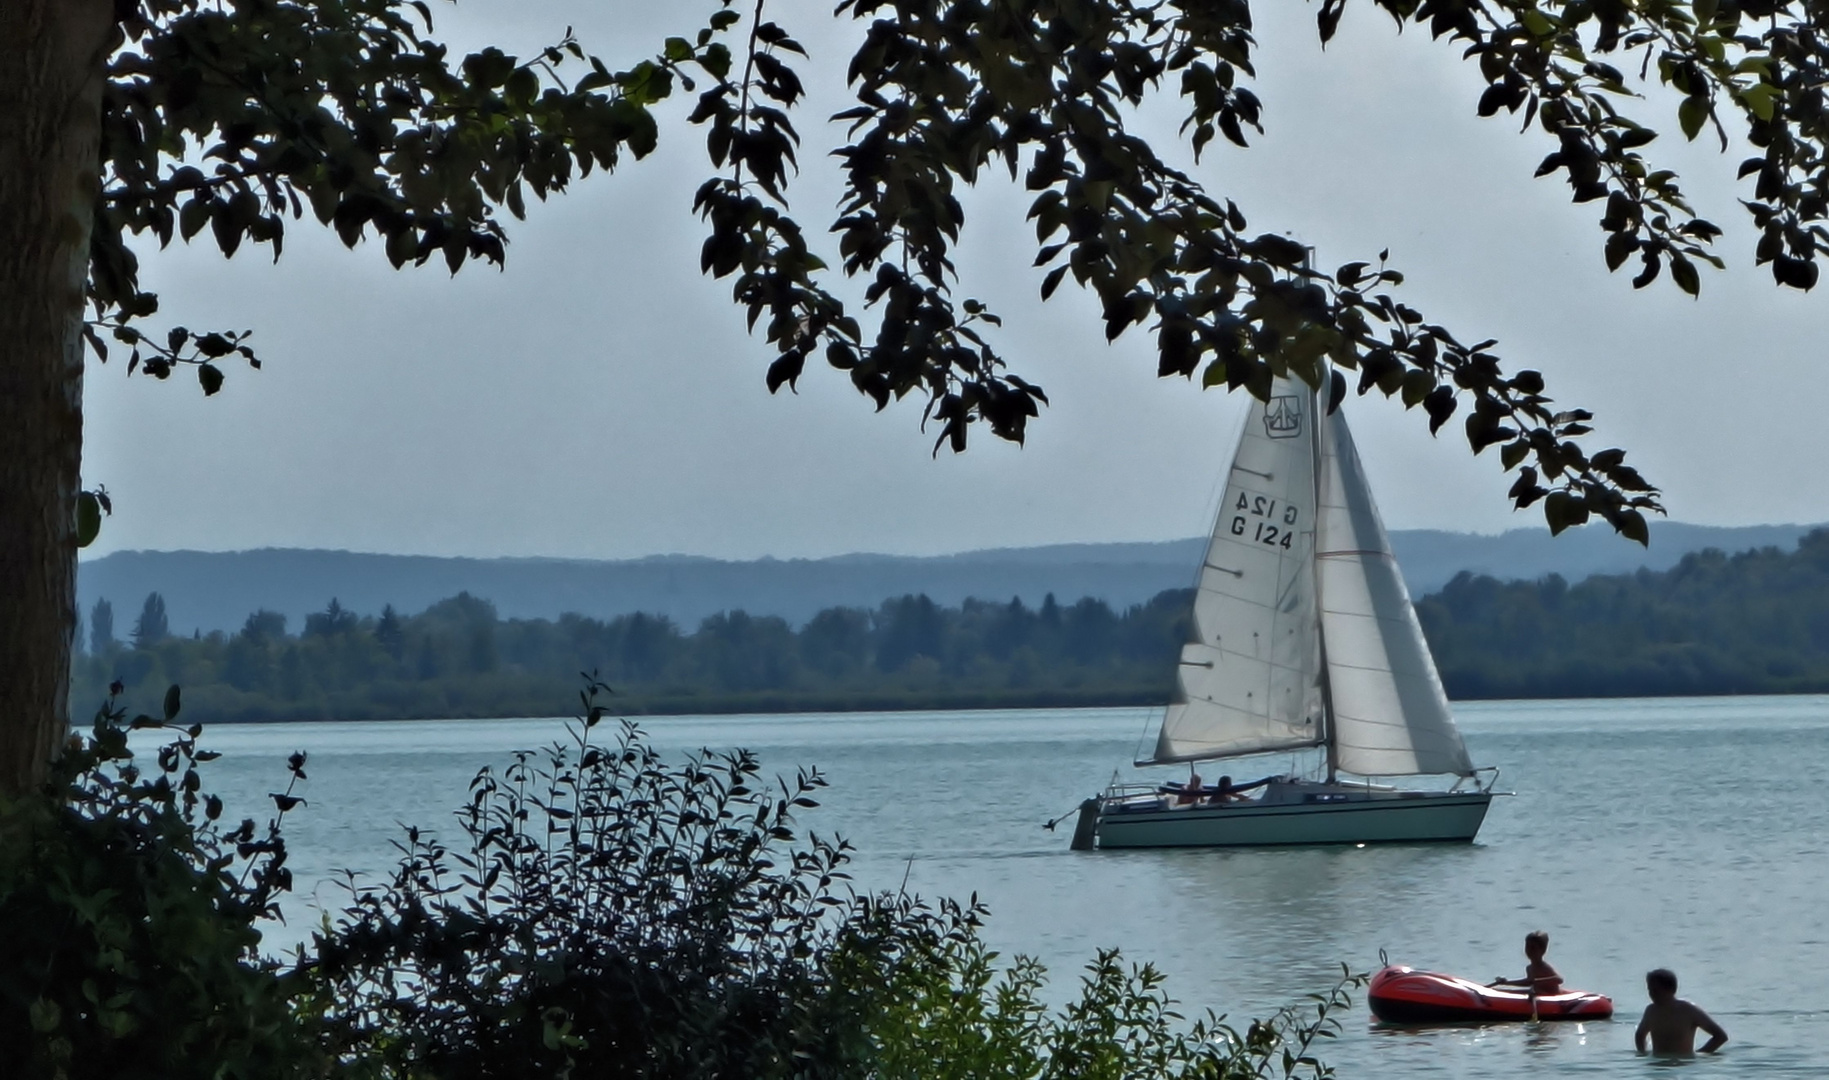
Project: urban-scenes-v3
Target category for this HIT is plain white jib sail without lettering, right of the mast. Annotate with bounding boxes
[1315,412,1472,776]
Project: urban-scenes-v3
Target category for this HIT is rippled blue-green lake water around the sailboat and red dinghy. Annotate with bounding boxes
[189,697,1829,1080]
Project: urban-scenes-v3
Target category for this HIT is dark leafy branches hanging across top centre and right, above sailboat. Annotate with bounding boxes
[693,0,1829,542]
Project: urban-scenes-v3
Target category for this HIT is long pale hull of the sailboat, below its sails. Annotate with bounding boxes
[1090,791,1492,849]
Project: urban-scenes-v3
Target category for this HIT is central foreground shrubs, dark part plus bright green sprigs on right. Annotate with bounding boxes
[315,686,1359,1080]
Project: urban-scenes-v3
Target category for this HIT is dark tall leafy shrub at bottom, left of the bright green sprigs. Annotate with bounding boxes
[316,686,975,1080]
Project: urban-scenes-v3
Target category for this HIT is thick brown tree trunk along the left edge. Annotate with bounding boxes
[0,0,113,794]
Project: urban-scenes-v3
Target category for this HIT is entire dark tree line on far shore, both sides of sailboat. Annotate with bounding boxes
[73,531,1829,721]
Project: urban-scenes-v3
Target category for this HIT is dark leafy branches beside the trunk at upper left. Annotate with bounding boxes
[88,0,730,394]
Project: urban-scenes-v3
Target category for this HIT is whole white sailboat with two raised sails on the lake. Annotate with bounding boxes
[1074,379,1496,849]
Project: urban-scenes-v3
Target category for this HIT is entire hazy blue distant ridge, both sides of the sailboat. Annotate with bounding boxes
[77,522,1816,637]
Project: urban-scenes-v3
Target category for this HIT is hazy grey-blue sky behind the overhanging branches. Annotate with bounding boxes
[74,0,1829,558]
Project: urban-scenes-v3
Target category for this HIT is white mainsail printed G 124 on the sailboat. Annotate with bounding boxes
[1139,379,1321,763]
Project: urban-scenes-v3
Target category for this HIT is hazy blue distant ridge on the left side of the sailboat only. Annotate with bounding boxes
[77,542,1200,635]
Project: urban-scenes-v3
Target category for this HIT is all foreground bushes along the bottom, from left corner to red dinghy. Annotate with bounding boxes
[0,686,1352,1080]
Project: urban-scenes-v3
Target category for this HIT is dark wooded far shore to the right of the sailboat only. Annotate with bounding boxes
[1416,531,1829,697]
